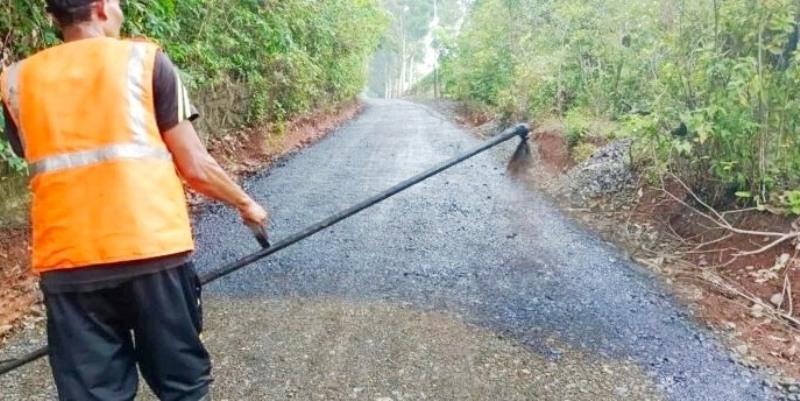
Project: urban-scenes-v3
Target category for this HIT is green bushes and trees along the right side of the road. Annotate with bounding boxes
[441,0,800,211]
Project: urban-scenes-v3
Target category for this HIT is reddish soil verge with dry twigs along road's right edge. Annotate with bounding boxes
[415,99,800,390]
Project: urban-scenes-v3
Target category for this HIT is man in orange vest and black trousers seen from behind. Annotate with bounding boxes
[0,0,268,401]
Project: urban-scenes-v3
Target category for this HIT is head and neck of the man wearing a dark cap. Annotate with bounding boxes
[47,0,124,38]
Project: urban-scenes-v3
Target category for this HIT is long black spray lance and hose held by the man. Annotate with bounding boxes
[0,124,530,375]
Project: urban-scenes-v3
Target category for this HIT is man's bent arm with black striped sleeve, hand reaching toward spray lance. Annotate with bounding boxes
[153,52,268,226]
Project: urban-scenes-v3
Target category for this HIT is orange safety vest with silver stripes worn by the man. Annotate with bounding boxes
[0,38,194,273]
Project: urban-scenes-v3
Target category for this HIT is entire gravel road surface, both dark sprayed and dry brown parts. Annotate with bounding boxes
[0,100,777,401]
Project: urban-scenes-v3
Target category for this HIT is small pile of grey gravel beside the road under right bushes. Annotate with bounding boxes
[559,139,634,200]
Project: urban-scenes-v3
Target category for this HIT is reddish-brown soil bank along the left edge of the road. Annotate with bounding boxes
[0,102,363,347]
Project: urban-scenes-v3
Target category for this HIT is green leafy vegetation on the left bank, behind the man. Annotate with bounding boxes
[0,0,389,225]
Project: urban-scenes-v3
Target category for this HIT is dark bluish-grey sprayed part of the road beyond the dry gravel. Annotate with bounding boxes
[188,101,773,400]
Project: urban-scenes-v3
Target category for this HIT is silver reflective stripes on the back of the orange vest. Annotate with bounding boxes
[27,43,172,178]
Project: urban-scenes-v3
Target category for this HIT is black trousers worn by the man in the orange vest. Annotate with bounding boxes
[44,263,211,401]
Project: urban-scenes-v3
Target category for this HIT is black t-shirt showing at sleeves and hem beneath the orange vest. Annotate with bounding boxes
[3,51,198,293]
